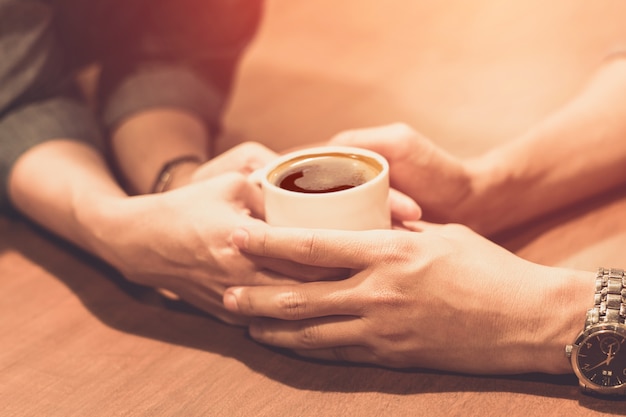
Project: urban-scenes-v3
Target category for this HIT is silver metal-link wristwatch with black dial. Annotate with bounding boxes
[565,268,626,395]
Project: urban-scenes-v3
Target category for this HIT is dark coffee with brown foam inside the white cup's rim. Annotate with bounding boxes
[270,153,382,193]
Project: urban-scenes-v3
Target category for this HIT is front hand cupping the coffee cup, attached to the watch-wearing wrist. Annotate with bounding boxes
[224,224,593,373]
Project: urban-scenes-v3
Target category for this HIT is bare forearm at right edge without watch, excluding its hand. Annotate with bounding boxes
[467,54,626,234]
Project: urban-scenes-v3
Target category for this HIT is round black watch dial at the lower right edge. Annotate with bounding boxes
[576,331,626,387]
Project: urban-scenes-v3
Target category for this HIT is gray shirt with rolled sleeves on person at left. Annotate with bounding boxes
[0,0,262,212]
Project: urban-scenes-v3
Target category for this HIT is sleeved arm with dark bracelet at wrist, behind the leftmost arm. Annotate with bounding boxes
[100,0,260,194]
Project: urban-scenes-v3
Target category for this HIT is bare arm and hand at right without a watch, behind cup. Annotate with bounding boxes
[334,55,626,235]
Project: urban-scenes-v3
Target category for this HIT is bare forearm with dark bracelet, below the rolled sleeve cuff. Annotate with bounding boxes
[111,108,210,194]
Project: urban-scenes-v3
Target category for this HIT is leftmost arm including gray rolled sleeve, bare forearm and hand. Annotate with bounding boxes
[0,0,316,324]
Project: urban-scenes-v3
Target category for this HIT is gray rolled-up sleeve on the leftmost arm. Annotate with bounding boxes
[0,0,101,211]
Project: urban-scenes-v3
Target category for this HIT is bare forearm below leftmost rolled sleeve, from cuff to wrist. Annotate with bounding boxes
[8,140,126,261]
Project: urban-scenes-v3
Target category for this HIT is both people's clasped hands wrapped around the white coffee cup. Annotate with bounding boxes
[118,124,593,373]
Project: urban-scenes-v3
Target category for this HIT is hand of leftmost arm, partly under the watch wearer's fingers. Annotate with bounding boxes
[100,173,345,324]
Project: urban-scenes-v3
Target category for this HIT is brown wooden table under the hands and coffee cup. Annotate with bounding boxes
[0,0,626,417]
